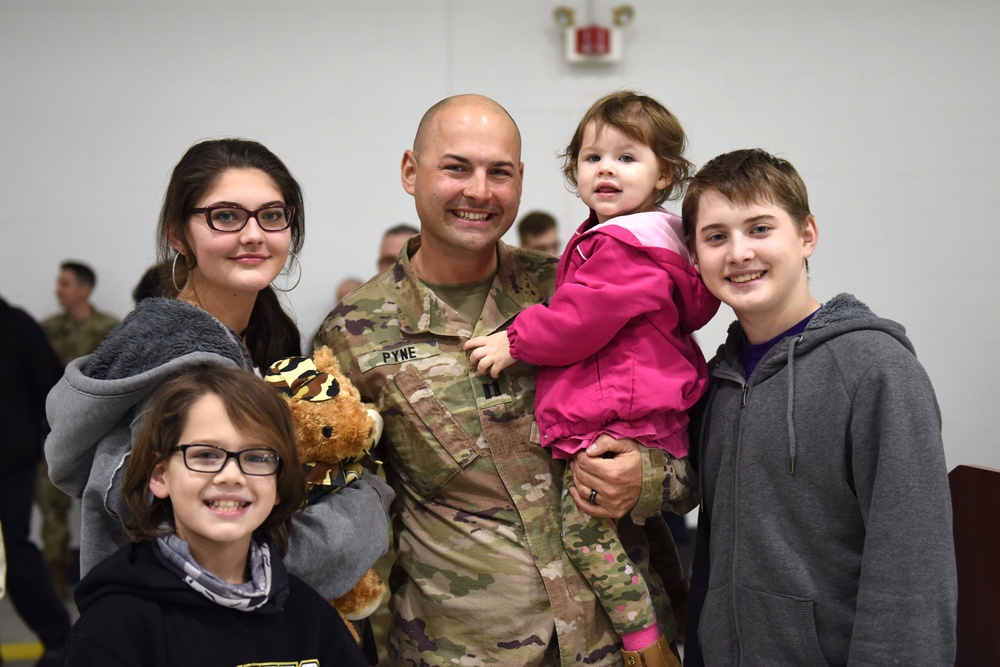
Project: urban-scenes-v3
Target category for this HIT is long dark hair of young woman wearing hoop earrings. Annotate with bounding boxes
[157,139,305,369]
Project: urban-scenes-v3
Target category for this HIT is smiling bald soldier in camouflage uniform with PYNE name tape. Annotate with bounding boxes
[315,96,694,667]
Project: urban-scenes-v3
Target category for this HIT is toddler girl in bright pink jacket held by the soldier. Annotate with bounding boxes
[466,92,719,664]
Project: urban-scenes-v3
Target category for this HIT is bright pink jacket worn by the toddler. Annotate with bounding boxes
[507,208,719,458]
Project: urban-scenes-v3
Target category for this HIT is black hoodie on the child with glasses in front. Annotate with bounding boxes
[63,542,368,667]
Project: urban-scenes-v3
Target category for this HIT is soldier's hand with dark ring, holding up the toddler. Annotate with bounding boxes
[570,433,642,519]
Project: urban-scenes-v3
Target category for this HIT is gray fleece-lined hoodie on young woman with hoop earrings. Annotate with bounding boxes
[45,298,394,598]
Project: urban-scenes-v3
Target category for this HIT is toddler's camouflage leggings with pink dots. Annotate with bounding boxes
[562,466,656,635]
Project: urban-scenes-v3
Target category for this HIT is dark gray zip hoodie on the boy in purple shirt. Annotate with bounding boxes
[685,294,957,666]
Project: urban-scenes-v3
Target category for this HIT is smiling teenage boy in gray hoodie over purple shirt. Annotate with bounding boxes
[683,150,957,667]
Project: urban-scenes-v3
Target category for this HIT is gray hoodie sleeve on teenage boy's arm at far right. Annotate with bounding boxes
[849,345,957,665]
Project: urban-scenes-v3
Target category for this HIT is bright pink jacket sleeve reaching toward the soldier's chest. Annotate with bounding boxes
[508,234,678,366]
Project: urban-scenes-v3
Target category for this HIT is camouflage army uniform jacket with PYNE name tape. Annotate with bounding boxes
[315,236,693,667]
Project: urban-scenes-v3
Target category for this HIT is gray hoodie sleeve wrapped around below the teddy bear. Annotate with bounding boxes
[283,474,395,599]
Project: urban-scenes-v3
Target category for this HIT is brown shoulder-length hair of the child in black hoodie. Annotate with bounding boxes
[122,366,305,555]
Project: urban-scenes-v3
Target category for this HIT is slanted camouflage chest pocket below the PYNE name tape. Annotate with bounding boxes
[386,364,483,499]
